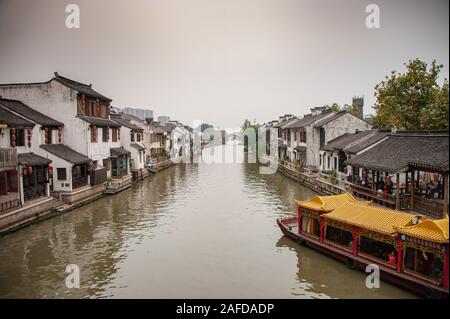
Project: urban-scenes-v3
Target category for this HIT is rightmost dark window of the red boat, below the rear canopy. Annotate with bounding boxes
[403,247,444,280]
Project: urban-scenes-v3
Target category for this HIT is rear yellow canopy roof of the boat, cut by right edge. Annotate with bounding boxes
[394,216,449,244]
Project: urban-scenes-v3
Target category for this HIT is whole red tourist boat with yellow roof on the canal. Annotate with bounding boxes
[277,194,449,298]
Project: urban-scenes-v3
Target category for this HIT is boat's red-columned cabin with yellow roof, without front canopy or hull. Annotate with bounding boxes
[321,202,449,289]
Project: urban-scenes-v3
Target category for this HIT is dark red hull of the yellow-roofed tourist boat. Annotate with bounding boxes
[277,217,449,299]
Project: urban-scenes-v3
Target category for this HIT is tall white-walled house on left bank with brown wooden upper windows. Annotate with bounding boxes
[0,73,131,199]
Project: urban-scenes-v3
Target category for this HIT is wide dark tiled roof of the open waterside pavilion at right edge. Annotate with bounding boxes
[347,133,449,173]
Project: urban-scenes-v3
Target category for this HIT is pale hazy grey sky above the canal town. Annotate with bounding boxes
[0,0,449,128]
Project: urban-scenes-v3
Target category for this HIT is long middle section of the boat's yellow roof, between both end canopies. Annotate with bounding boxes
[323,202,417,235]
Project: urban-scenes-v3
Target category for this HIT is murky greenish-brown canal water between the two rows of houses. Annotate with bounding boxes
[0,144,414,298]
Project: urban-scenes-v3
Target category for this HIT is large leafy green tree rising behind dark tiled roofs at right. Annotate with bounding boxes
[374,59,449,130]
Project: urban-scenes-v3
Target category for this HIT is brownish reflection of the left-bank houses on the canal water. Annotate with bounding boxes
[0,164,198,298]
